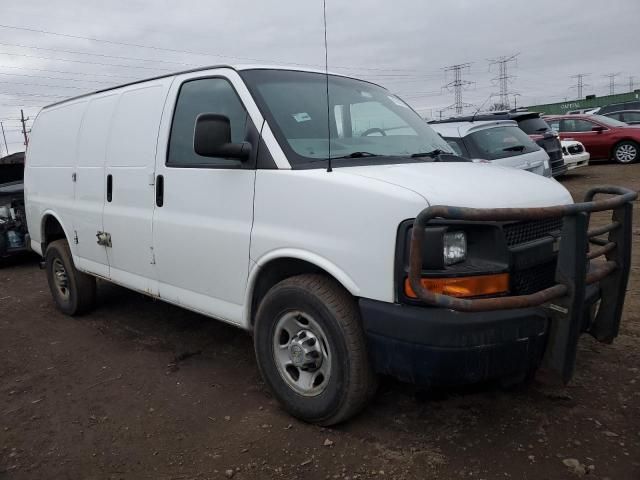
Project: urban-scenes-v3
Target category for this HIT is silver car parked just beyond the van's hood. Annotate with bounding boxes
[431,120,551,177]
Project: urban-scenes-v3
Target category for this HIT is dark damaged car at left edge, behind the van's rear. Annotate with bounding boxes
[0,152,29,259]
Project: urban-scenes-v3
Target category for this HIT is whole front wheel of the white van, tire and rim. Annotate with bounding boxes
[254,274,376,426]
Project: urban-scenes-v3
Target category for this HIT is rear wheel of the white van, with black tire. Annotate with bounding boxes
[45,240,96,316]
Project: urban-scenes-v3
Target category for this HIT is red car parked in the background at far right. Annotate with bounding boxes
[544,115,640,163]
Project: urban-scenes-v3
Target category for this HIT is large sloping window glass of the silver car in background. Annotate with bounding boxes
[465,126,540,160]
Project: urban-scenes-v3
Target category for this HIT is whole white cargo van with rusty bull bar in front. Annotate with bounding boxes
[25,66,635,425]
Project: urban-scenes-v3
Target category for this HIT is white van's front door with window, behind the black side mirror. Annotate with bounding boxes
[153,69,262,323]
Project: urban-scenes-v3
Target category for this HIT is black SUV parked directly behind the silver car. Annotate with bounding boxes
[429,110,567,177]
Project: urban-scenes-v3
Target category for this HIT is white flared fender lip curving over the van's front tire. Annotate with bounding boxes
[243,248,360,326]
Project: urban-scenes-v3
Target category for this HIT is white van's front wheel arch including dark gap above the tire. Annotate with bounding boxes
[245,249,360,330]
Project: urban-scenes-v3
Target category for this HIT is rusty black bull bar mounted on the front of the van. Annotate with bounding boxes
[409,185,638,382]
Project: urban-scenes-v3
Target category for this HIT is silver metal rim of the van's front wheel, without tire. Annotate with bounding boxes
[273,311,331,396]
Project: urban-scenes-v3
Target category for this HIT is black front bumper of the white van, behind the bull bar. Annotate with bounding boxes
[359,285,600,385]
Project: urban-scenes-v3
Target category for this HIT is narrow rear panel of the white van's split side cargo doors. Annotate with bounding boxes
[73,92,119,278]
